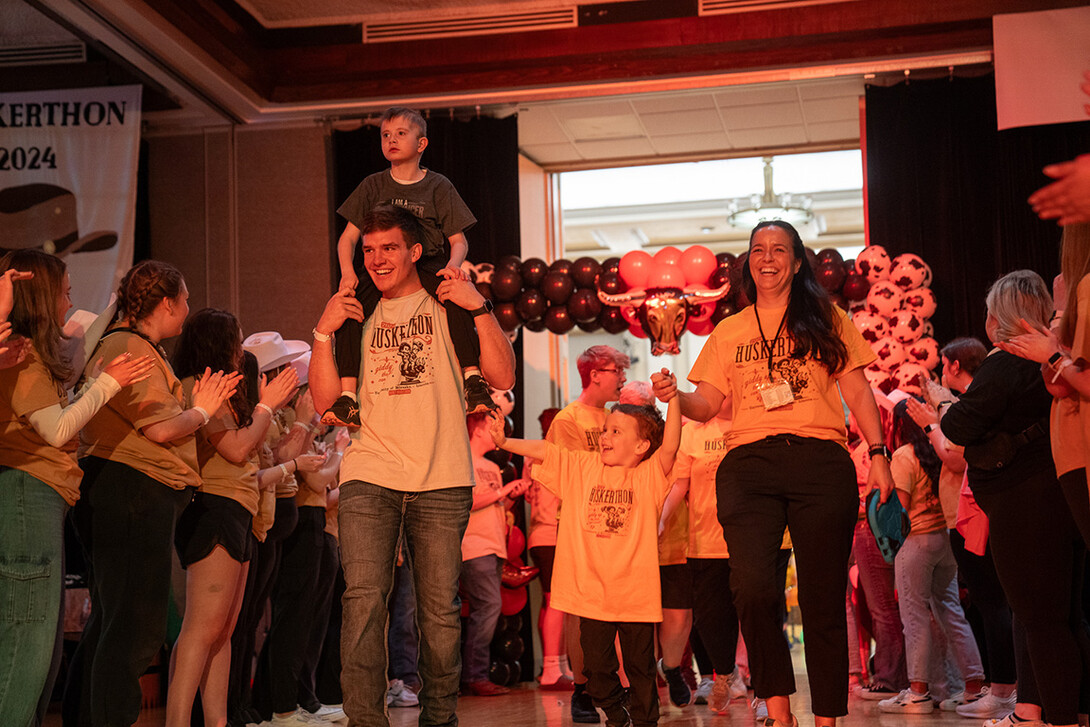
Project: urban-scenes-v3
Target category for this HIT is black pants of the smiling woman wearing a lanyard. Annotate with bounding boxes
[716,435,859,717]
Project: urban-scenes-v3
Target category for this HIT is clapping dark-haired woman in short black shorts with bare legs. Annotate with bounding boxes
[167,308,299,727]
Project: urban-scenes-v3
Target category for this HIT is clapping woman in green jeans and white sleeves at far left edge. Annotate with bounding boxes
[0,250,152,727]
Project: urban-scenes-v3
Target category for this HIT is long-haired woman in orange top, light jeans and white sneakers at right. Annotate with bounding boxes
[879,401,984,714]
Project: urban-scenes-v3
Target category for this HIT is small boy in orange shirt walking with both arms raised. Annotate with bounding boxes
[491,368,681,727]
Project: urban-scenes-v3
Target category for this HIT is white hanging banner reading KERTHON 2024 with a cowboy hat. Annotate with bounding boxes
[0,86,141,311]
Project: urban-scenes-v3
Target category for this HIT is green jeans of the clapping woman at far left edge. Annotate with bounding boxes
[0,469,68,727]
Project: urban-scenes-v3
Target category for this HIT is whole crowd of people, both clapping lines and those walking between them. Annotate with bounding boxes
[0,99,1090,727]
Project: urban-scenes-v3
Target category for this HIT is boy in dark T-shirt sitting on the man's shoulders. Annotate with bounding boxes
[322,106,495,431]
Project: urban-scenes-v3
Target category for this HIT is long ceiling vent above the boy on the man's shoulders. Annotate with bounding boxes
[363,7,578,43]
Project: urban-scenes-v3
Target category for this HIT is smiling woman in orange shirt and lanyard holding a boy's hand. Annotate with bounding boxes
[652,220,893,727]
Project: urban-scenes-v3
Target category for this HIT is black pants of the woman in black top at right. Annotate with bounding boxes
[970,467,1090,725]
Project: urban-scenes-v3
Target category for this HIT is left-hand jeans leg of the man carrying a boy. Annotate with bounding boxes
[338,481,405,726]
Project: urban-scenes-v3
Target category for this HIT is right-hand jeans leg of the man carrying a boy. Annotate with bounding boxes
[401,487,473,727]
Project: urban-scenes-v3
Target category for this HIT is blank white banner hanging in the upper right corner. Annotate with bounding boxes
[992,7,1090,130]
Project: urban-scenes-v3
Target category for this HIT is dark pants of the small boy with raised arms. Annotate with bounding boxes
[579,618,658,727]
